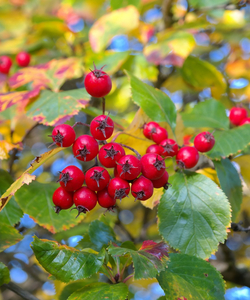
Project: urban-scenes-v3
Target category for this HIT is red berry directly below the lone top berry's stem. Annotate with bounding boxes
[90,115,114,141]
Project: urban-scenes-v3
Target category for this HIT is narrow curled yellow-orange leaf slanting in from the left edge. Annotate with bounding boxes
[0,147,64,211]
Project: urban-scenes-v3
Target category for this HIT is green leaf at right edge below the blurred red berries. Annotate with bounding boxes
[206,124,250,159]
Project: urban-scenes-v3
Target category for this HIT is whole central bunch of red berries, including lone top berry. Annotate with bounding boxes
[51,66,215,216]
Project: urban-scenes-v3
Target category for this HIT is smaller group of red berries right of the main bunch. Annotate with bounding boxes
[143,122,215,169]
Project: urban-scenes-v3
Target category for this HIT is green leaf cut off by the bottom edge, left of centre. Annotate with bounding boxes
[68,282,128,300]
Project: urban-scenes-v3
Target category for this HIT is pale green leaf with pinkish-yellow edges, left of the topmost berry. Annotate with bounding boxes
[27,89,90,126]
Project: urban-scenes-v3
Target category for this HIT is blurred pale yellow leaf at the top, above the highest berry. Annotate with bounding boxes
[89,5,139,52]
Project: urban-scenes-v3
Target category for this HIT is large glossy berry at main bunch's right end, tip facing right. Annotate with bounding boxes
[141,153,166,180]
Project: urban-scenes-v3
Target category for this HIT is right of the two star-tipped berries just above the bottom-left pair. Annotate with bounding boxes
[85,167,110,191]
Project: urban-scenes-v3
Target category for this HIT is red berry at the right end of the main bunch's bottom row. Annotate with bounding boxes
[131,175,154,201]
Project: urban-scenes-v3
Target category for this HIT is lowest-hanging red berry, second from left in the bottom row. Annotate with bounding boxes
[73,186,97,217]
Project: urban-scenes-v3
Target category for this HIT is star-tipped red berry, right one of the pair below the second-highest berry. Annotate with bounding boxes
[98,143,125,168]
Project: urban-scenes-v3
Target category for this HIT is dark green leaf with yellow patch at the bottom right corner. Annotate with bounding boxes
[157,253,225,300]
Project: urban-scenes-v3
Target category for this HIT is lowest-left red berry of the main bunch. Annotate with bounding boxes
[52,187,74,214]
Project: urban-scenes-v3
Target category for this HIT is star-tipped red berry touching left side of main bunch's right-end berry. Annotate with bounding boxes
[116,155,142,180]
